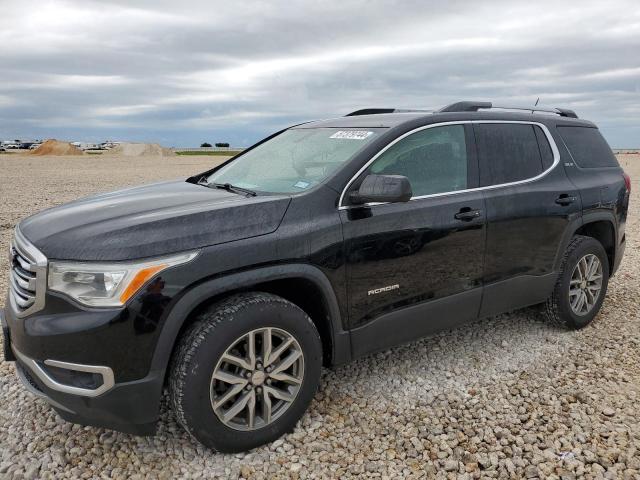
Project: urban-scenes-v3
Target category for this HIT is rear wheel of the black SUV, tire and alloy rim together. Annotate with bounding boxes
[546,235,609,329]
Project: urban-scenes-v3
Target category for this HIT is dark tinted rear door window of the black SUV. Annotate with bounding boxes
[475,123,542,185]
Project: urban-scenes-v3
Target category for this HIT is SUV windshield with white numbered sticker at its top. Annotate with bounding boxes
[207,128,382,193]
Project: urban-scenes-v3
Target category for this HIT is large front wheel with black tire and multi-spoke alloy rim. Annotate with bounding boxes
[169,292,322,453]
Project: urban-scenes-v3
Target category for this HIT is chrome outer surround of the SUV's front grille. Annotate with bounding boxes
[9,226,47,318]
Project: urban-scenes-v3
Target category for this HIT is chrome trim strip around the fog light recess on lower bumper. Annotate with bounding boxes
[11,345,115,397]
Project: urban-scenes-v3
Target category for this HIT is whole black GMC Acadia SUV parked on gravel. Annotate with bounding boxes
[2,102,631,452]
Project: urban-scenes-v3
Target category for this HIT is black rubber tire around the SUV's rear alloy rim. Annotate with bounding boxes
[545,235,609,330]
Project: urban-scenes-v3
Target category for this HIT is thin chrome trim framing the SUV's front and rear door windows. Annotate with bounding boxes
[338,120,560,210]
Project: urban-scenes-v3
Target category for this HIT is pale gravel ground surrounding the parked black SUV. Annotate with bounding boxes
[0,155,640,479]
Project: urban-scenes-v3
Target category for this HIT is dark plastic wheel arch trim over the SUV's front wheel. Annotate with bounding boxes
[151,264,351,382]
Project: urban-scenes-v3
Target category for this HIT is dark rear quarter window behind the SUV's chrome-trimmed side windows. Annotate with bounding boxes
[558,127,618,168]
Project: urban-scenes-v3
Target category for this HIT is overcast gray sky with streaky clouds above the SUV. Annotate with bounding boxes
[0,0,640,148]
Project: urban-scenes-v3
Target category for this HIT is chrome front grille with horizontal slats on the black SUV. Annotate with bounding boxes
[9,228,47,317]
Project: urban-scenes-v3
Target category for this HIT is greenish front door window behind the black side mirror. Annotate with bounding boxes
[369,125,467,196]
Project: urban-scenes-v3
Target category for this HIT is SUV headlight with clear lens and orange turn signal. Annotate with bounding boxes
[48,252,198,307]
